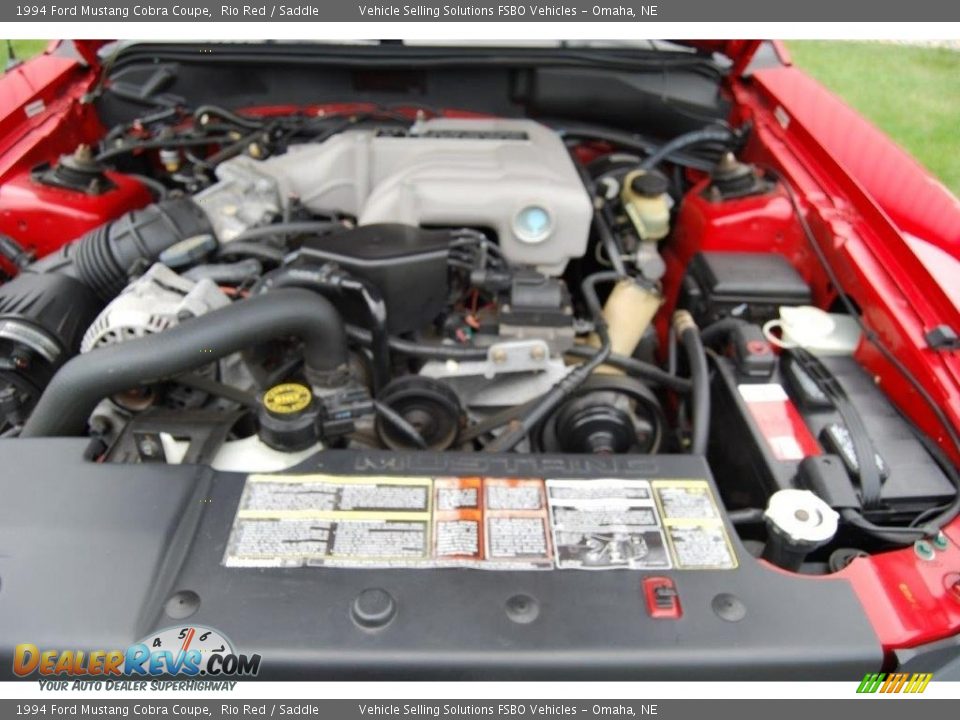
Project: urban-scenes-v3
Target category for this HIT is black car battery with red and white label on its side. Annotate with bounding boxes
[708,353,954,521]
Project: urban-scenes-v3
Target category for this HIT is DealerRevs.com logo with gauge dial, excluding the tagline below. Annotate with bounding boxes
[13,626,260,680]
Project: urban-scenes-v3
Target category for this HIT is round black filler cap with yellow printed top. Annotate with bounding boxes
[257,383,318,452]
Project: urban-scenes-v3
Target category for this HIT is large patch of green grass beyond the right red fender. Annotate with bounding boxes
[787,41,960,196]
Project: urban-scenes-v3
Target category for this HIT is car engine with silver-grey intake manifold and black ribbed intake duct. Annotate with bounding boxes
[3,118,665,462]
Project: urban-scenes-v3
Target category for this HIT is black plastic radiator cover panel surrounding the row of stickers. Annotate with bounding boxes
[0,439,882,680]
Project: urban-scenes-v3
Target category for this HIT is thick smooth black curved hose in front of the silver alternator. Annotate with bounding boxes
[20,289,349,438]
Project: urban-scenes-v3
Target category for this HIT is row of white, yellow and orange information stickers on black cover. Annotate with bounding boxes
[224,475,737,570]
